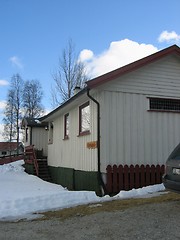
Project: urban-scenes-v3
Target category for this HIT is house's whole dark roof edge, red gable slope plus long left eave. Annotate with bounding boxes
[41,45,180,121]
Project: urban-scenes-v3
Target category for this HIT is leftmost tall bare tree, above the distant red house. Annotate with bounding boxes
[4,74,24,153]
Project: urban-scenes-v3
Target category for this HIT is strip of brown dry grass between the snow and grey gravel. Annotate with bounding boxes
[39,193,180,221]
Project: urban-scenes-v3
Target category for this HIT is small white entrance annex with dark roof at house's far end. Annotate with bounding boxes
[21,117,48,156]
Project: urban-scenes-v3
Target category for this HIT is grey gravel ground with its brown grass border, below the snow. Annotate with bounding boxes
[0,193,180,240]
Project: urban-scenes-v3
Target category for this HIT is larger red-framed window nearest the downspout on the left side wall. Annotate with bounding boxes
[79,102,90,135]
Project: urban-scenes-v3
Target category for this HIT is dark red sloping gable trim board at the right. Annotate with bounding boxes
[86,45,180,88]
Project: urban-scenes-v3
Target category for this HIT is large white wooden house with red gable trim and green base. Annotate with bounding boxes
[41,45,180,195]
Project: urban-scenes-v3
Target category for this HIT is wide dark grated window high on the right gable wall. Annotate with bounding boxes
[149,98,180,112]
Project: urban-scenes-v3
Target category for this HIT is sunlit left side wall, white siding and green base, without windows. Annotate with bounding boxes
[48,96,99,193]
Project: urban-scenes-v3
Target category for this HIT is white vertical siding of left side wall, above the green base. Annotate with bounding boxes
[48,98,97,171]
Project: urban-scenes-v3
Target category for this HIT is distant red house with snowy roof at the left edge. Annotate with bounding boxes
[0,142,24,157]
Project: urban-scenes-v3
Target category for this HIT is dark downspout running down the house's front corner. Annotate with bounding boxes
[87,88,107,194]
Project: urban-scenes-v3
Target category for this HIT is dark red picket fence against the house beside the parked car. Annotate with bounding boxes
[106,165,165,194]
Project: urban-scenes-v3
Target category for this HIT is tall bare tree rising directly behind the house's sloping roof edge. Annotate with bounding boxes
[51,40,88,106]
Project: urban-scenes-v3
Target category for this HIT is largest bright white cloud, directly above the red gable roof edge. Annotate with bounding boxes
[80,39,158,77]
